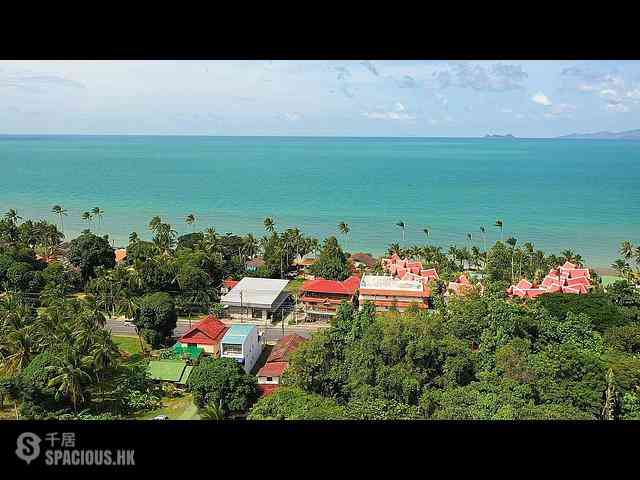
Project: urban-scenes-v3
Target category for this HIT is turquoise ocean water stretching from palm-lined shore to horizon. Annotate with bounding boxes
[0,136,640,266]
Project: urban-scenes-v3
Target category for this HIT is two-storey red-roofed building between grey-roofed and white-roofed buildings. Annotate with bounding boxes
[299,275,360,321]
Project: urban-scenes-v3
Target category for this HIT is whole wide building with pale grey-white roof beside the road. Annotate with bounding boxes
[220,277,289,321]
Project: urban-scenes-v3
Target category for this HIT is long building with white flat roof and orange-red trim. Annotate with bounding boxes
[358,275,431,312]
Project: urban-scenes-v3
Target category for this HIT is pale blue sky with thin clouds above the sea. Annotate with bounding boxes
[0,60,640,137]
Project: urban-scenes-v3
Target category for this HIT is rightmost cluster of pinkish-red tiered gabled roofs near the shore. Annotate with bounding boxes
[507,262,591,298]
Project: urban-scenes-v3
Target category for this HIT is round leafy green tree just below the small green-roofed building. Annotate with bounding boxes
[188,357,258,414]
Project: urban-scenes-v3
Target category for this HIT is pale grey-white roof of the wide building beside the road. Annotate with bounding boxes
[220,277,289,309]
